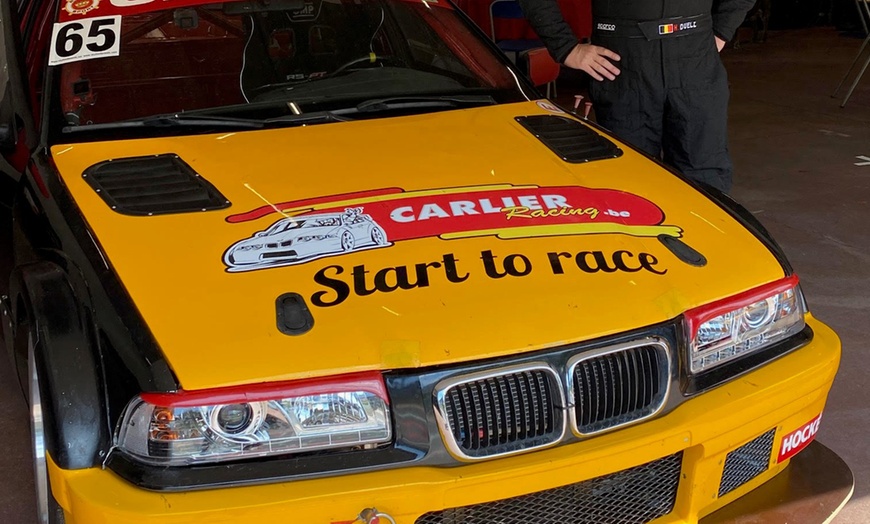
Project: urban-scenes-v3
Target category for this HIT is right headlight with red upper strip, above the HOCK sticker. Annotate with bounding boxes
[685,275,806,373]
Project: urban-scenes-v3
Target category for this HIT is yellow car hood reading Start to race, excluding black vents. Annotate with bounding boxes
[52,102,783,390]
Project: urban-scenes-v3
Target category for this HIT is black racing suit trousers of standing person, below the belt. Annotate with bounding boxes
[590,25,733,192]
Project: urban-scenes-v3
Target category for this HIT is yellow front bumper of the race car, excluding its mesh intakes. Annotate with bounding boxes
[49,318,840,524]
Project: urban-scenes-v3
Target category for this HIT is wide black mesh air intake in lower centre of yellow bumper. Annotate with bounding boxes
[416,452,682,524]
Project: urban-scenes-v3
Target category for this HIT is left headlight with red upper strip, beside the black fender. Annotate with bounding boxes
[117,373,392,466]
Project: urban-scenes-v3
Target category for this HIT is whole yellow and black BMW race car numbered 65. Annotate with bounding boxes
[0,0,851,524]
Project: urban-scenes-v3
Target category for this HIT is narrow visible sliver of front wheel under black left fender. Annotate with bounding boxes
[27,333,65,524]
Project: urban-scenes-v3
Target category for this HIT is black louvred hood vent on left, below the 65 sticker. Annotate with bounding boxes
[82,154,230,216]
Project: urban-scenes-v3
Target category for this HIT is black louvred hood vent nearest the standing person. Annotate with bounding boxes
[516,115,622,164]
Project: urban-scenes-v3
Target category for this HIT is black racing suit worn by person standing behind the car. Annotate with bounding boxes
[519,0,755,191]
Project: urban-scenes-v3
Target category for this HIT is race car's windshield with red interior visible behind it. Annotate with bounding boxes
[50,0,525,138]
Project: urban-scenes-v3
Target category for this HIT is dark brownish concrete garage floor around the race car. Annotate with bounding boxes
[0,28,870,524]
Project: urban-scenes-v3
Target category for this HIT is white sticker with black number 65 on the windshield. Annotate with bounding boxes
[48,15,121,66]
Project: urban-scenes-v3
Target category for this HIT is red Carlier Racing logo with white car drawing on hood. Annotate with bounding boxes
[223,184,682,272]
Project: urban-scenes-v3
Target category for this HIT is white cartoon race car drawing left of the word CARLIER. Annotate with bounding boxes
[224,208,387,271]
